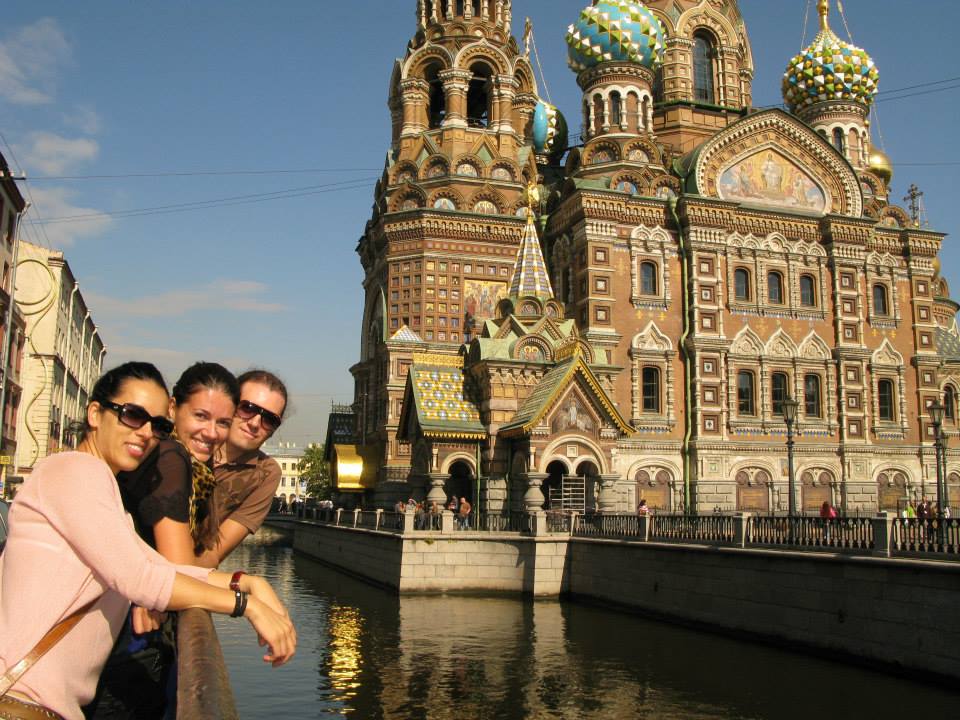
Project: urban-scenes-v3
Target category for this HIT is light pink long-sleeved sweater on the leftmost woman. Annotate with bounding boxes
[0,452,210,720]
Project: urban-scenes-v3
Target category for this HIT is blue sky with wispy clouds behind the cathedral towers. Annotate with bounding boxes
[0,0,960,445]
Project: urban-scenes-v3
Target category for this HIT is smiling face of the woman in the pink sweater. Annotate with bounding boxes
[84,379,169,474]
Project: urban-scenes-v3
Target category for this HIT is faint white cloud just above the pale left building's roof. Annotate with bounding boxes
[24,185,113,249]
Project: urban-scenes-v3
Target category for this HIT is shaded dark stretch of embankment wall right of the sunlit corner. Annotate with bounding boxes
[568,539,960,679]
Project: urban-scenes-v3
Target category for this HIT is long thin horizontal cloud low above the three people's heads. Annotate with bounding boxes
[86,280,286,318]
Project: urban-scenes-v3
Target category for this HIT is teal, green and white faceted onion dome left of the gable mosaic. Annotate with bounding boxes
[567,0,665,73]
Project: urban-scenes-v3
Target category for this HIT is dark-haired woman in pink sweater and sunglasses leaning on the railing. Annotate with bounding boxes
[0,363,296,720]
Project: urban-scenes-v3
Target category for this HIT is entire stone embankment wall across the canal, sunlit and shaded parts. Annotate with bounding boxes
[294,523,960,680]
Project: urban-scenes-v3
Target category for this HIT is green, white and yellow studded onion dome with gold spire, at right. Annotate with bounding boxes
[783,0,880,112]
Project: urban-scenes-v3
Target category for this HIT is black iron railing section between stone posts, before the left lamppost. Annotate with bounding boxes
[747,515,874,550]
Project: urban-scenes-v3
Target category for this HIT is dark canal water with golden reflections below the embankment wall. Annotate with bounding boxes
[217,531,960,720]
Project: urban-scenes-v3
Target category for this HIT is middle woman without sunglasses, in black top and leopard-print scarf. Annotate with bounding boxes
[84,362,239,718]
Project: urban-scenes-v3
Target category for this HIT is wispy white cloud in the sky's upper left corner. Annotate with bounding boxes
[0,18,71,105]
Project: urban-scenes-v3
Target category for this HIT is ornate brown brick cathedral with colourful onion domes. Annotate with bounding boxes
[327,0,960,513]
